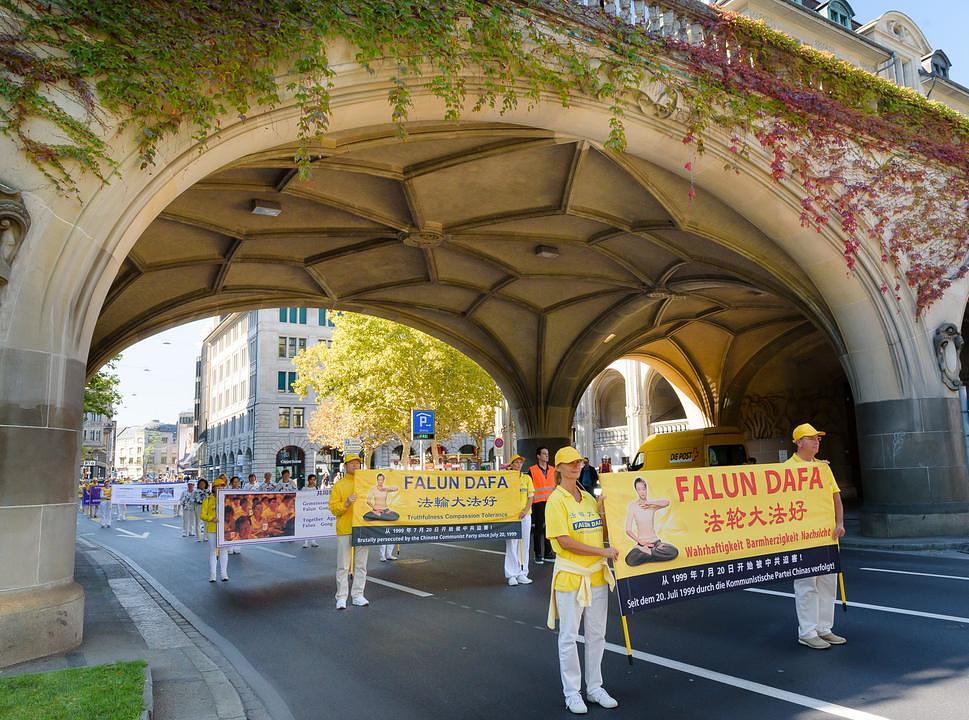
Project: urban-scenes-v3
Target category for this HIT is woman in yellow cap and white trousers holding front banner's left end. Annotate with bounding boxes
[545,447,619,715]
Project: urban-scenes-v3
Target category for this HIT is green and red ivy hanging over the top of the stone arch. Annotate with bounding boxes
[0,0,969,312]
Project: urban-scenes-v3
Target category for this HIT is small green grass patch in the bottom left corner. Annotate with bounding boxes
[0,660,145,720]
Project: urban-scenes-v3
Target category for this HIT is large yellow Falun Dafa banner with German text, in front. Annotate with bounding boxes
[600,463,838,612]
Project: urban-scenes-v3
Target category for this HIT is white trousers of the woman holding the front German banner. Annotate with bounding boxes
[555,585,609,699]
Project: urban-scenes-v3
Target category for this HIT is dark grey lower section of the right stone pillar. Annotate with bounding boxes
[855,397,969,537]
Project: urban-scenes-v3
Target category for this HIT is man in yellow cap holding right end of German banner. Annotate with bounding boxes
[786,423,848,650]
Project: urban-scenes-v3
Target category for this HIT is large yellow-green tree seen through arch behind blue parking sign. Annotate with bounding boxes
[293,313,502,466]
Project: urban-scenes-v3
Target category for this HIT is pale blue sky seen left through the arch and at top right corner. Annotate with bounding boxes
[111,0,969,427]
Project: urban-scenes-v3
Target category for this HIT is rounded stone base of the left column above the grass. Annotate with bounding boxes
[0,581,84,667]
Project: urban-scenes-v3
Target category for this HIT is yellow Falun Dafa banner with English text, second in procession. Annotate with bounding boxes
[353,470,521,545]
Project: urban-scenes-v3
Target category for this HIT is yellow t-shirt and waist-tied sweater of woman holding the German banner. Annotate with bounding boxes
[545,487,606,592]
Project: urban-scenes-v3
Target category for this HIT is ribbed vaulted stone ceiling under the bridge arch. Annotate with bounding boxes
[91,123,844,432]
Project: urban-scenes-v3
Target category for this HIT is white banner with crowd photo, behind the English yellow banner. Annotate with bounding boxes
[216,488,336,547]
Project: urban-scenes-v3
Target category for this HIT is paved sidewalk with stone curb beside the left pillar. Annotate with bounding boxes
[0,538,272,720]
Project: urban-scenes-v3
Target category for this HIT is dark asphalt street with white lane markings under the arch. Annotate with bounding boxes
[78,514,969,720]
